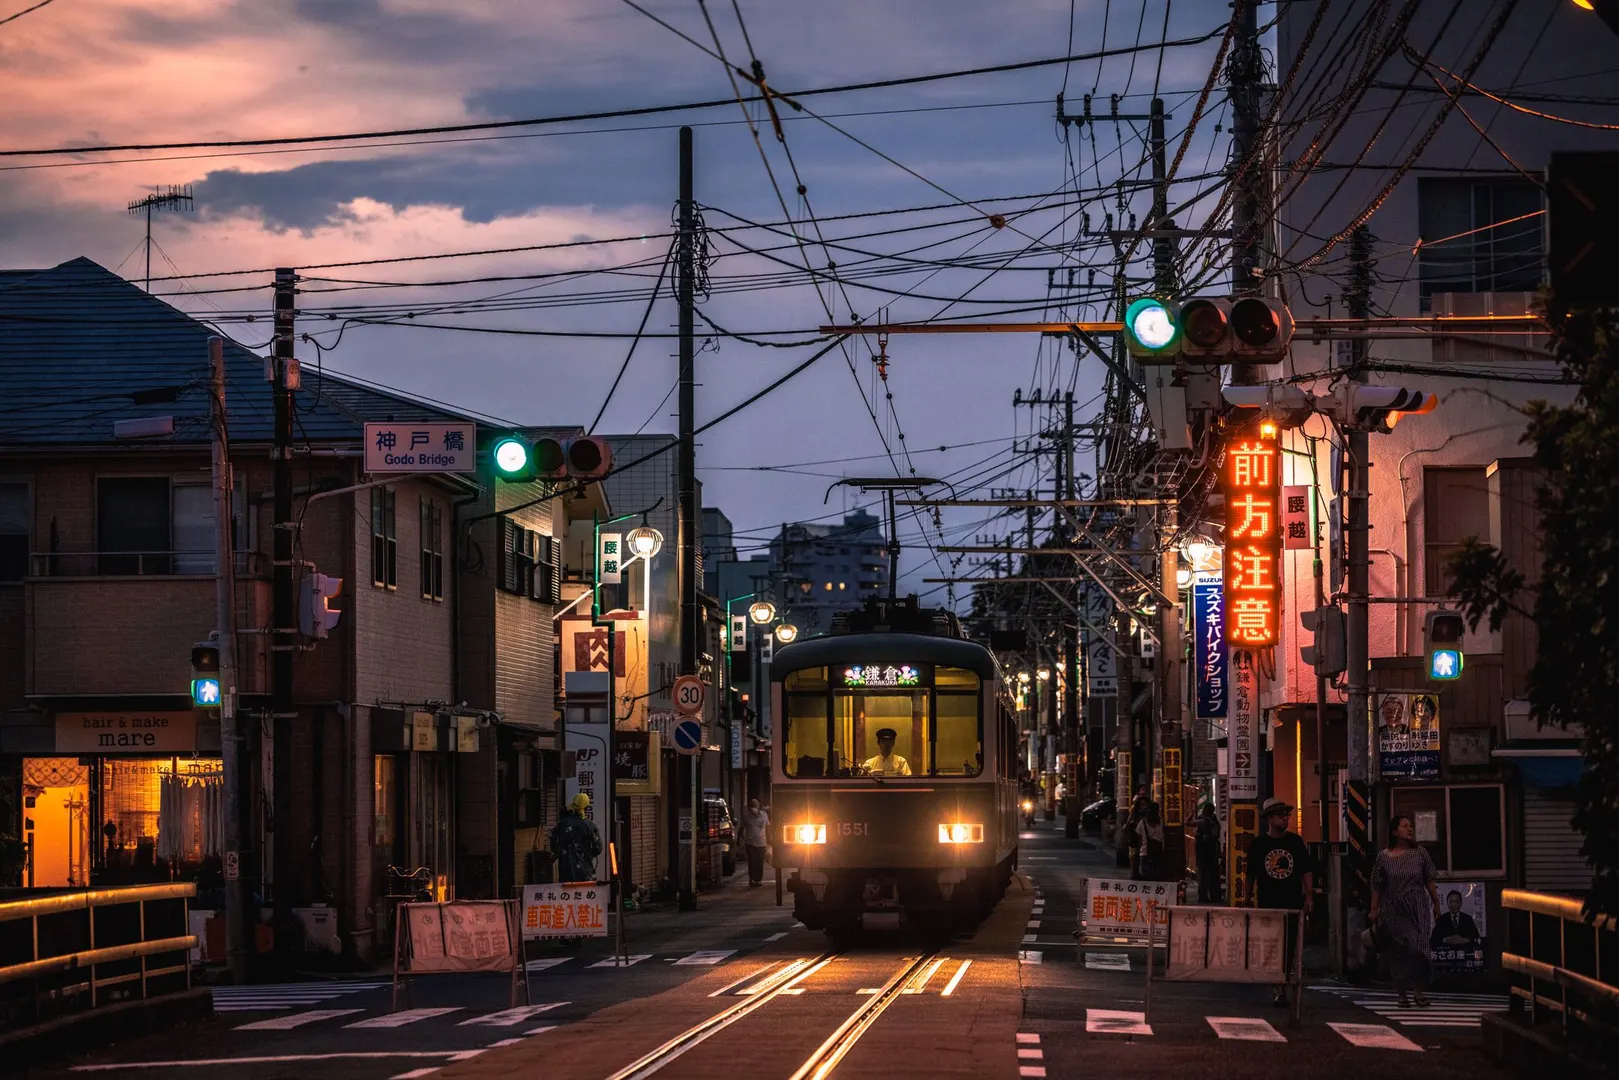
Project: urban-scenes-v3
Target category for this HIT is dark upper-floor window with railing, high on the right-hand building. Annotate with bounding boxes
[1417,176,1546,311]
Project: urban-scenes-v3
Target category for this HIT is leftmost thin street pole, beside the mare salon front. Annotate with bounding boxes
[207,337,253,986]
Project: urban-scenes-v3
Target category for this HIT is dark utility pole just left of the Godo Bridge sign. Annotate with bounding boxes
[270,267,298,926]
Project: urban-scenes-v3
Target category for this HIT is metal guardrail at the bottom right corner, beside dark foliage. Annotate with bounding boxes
[1501,889,1619,1043]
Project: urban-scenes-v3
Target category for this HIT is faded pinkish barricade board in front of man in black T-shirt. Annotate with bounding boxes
[1145,905,1305,1027]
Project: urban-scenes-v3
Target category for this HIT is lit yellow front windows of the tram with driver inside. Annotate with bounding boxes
[782,669,983,779]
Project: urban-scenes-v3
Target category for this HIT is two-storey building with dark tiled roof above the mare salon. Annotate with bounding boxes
[0,259,606,957]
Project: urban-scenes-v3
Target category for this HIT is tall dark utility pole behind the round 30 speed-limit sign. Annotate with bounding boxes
[670,128,703,912]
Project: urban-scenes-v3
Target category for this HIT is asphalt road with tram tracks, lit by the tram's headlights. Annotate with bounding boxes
[23,823,1504,1080]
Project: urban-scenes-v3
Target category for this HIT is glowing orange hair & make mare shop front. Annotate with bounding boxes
[5,708,225,887]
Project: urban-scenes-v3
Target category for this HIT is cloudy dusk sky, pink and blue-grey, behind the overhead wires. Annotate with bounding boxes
[0,0,1236,599]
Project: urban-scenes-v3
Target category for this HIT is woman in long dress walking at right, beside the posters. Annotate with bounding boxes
[1370,814,1460,1009]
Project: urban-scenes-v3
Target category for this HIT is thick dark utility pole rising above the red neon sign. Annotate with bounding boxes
[1227,0,1274,385]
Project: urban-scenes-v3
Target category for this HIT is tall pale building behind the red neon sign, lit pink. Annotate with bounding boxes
[1261,2,1619,919]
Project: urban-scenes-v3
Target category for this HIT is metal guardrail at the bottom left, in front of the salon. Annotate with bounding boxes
[0,882,198,1023]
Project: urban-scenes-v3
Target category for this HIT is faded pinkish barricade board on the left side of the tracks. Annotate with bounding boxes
[393,900,528,1009]
